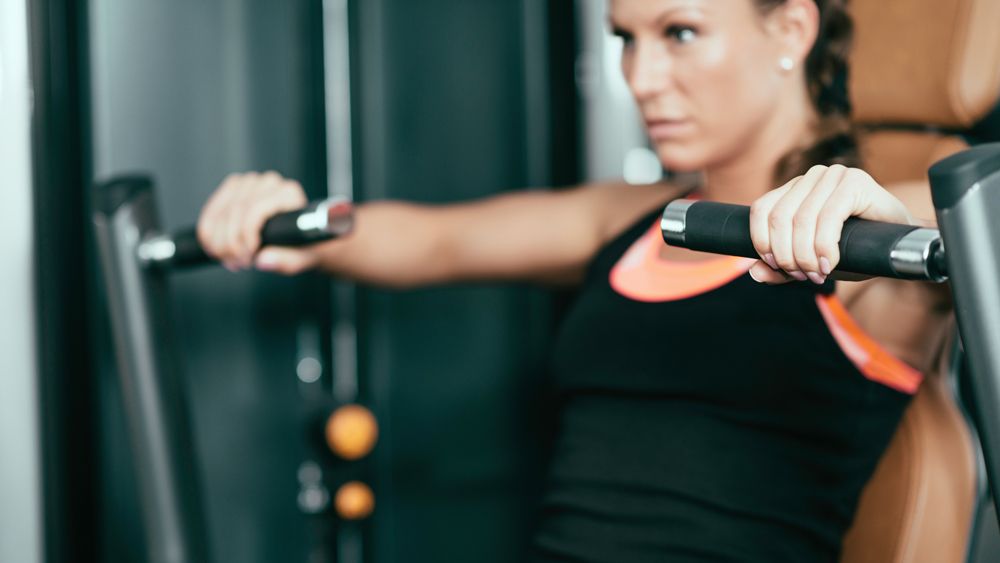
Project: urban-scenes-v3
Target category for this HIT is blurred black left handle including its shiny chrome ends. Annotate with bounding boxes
[138,199,354,268]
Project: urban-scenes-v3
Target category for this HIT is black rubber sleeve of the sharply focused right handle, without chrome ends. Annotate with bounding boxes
[679,201,919,278]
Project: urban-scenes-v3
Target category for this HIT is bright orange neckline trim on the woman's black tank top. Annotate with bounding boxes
[608,221,754,303]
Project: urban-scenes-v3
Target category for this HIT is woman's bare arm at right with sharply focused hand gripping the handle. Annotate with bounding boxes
[750,165,952,372]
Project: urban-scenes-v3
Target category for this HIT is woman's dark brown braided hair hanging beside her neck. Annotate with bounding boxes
[753,0,861,183]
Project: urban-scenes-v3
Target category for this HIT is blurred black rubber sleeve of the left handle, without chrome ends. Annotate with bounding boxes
[168,202,337,268]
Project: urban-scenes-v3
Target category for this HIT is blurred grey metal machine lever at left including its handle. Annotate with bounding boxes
[94,176,353,563]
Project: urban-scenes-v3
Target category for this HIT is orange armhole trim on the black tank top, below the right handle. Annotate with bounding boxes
[816,295,924,395]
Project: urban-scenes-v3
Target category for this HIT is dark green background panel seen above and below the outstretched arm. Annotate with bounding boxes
[355,0,571,563]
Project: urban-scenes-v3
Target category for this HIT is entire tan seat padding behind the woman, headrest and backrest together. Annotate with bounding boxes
[841,0,1000,563]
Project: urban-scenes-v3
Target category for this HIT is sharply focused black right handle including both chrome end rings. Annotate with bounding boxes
[660,199,947,281]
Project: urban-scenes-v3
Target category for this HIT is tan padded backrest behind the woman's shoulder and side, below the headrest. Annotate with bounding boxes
[841,132,978,563]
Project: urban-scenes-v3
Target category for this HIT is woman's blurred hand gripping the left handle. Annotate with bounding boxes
[197,172,319,275]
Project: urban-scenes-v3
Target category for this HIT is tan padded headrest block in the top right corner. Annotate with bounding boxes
[848,0,1000,128]
